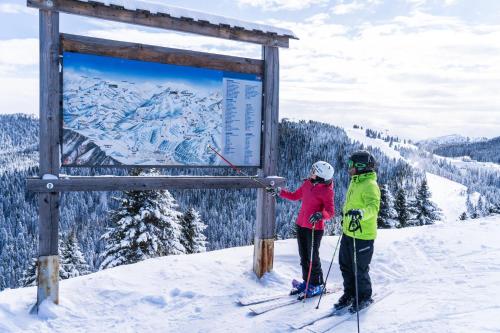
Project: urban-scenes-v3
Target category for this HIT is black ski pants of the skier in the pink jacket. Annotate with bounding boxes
[297,226,323,285]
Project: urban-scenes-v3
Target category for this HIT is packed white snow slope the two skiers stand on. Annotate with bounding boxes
[0,216,500,333]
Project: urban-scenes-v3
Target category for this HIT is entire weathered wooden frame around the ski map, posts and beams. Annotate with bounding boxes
[27,0,297,311]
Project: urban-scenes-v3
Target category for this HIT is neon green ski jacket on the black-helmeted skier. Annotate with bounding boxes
[342,172,380,240]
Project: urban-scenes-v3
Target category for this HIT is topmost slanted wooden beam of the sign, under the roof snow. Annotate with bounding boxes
[27,0,290,47]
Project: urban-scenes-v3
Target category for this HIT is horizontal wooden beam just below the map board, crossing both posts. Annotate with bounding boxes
[27,176,285,193]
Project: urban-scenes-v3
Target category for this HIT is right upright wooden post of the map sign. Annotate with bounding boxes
[253,46,279,278]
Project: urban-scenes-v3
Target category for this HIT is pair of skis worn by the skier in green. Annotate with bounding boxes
[290,291,393,333]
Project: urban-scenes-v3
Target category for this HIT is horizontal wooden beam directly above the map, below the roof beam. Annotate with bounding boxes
[61,34,264,75]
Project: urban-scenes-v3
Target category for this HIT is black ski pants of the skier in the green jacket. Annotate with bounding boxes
[339,234,374,300]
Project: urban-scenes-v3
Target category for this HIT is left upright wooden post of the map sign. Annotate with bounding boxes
[36,10,60,309]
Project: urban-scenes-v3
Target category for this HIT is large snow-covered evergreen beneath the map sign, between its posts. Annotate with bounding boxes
[100,171,185,269]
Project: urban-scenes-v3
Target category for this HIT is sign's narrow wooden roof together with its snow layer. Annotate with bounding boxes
[27,0,298,47]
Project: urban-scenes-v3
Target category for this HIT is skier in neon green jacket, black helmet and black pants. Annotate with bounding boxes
[334,150,380,312]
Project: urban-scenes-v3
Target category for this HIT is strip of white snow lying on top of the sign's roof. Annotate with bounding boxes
[78,0,298,39]
